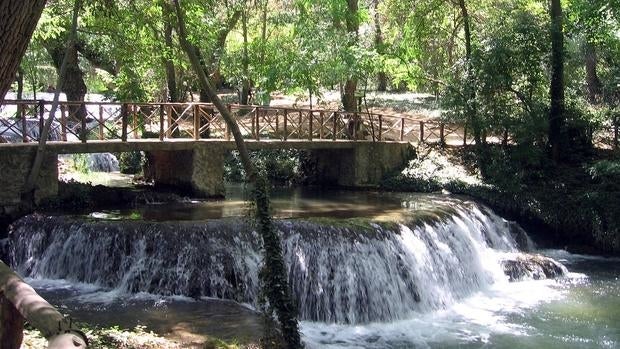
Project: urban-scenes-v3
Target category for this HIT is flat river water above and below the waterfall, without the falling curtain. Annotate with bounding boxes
[17,187,620,348]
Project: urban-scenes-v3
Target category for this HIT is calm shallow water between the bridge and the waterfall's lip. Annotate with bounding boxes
[85,185,452,221]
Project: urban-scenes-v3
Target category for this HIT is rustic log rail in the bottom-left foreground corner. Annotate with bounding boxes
[0,261,88,349]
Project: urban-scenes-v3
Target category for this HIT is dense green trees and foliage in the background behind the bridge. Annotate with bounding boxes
[10,0,620,152]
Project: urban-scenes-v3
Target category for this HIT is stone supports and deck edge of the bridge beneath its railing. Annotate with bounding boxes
[0,140,415,208]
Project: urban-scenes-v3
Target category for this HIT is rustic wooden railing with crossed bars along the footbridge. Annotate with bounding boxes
[0,101,467,143]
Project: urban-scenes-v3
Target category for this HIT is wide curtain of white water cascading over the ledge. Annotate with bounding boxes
[9,201,564,324]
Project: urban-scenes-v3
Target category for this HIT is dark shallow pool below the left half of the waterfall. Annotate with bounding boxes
[27,279,263,348]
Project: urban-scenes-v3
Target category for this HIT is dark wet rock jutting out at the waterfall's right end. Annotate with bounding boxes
[501,254,567,282]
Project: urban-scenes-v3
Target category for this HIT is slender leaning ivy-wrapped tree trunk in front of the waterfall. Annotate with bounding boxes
[173,0,302,349]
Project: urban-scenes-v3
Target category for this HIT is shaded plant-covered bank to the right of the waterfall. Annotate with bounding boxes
[382,143,620,255]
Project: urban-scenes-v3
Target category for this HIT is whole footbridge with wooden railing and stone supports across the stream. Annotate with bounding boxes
[0,101,426,208]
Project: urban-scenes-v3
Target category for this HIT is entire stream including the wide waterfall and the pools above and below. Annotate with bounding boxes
[2,186,620,348]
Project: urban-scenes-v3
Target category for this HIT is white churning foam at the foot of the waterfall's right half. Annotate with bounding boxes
[302,273,587,349]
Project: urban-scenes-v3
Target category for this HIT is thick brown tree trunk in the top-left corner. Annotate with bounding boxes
[0,0,45,104]
